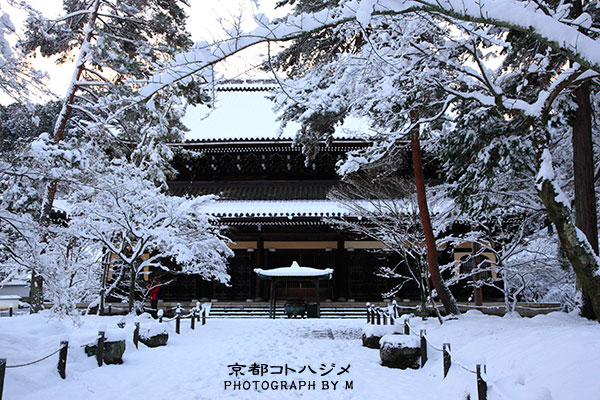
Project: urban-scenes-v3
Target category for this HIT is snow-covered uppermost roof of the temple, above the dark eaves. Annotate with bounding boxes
[182,80,368,140]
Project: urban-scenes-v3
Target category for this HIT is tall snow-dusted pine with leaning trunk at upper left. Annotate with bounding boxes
[12,0,205,311]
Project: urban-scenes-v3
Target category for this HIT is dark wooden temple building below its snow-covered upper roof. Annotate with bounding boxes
[155,139,436,301]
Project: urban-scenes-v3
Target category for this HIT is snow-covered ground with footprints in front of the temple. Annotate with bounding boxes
[0,311,600,400]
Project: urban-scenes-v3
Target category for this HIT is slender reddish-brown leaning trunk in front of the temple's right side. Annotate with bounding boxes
[410,128,460,314]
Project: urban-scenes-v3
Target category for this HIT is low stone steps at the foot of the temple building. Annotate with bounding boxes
[210,302,367,320]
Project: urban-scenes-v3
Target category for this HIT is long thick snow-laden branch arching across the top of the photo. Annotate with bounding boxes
[140,0,600,101]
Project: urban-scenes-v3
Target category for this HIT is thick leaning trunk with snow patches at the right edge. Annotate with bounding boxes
[537,150,600,319]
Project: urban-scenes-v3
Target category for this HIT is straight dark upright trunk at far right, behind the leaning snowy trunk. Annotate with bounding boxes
[572,0,598,319]
